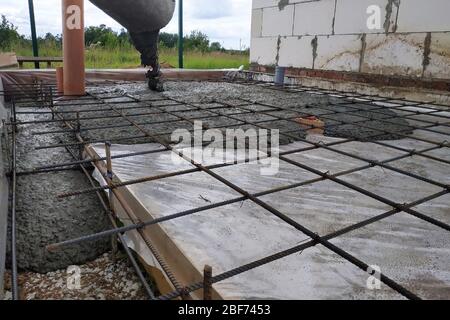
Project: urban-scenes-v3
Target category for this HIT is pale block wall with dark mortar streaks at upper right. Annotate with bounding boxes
[250,0,450,79]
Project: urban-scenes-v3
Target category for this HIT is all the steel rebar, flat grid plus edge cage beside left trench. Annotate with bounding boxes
[0,80,450,299]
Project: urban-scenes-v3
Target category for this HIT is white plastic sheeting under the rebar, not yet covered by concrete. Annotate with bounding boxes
[94,131,450,299]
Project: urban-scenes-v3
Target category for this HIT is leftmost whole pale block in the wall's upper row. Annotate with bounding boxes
[262,5,294,37]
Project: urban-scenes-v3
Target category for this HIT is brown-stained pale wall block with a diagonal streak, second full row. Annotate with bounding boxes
[314,35,362,72]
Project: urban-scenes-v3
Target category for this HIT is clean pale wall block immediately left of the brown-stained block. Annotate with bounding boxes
[278,36,314,68]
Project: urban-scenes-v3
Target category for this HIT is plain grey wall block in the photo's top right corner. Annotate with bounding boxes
[397,0,450,32]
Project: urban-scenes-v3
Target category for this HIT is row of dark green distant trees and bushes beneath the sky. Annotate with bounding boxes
[0,15,244,52]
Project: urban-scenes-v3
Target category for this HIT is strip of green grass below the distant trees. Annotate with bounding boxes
[5,45,249,69]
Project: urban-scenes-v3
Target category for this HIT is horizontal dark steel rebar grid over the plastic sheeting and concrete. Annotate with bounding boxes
[4,77,450,299]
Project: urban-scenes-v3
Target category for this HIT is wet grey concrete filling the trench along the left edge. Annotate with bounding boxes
[7,103,110,272]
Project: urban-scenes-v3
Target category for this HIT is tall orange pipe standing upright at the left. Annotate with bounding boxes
[62,0,86,96]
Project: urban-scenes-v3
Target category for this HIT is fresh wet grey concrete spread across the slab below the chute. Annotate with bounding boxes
[61,81,412,145]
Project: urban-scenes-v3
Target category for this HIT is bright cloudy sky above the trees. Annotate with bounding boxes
[0,0,252,49]
